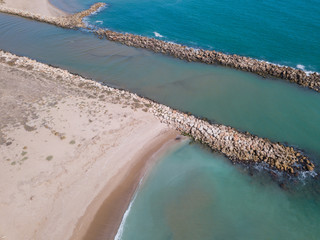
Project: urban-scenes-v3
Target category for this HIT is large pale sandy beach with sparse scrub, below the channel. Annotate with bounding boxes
[0,52,178,240]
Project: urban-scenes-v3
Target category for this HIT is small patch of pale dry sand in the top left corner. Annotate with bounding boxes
[0,0,67,17]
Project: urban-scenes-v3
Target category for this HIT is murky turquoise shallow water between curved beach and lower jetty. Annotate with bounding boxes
[117,145,320,240]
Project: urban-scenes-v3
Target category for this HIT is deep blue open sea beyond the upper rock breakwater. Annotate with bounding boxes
[89,0,320,71]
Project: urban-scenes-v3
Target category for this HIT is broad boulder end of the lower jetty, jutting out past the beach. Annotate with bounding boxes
[153,104,314,174]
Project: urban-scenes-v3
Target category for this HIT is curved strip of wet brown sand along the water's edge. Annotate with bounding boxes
[70,133,183,240]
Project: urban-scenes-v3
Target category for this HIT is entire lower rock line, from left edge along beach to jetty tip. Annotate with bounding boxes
[0,50,315,175]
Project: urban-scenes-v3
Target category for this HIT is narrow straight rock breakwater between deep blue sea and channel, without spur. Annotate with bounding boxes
[96,29,320,92]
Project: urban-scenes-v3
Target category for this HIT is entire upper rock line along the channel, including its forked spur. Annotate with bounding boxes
[0,3,320,92]
